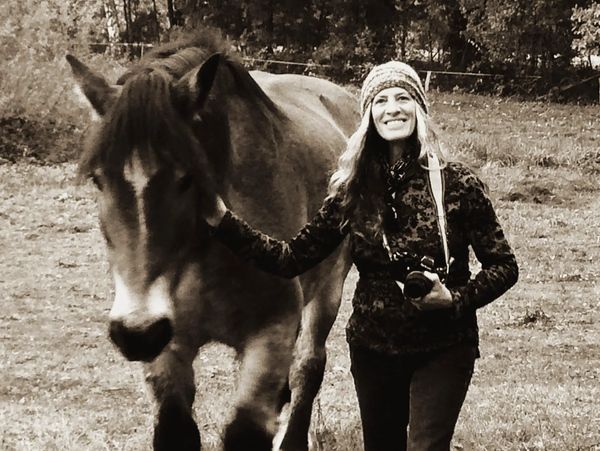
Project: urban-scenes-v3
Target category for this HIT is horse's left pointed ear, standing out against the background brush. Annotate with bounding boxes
[66,55,120,116]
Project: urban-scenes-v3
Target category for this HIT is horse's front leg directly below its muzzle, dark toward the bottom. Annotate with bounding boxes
[144,343,201,451]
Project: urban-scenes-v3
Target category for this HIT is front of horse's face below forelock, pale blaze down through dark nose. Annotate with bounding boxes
[99,153,180,360]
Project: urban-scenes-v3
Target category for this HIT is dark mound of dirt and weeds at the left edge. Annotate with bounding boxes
[0,117,82,164]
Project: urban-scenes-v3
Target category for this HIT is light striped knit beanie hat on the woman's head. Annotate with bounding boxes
[360,61,428,115]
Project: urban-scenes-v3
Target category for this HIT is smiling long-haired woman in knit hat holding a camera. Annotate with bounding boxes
[206,61,518,451]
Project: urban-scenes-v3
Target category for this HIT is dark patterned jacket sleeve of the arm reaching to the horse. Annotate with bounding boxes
[215,199,346,279]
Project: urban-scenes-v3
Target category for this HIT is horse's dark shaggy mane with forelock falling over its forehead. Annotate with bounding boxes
[79,30,277,180]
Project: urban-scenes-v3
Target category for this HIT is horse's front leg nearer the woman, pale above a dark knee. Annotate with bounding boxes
[223,313,298,451]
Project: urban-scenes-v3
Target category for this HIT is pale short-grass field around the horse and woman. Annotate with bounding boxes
[0,93,600,451]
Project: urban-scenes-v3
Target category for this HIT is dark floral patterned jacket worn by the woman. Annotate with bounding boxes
[215,163,518,354]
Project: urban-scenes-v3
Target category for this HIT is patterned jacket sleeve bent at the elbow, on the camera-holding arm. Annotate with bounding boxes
[450,174,519,315]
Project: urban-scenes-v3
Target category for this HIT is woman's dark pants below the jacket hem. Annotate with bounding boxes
[350,344,479,451]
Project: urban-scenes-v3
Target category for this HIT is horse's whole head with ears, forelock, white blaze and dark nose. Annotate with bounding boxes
[67,51,227,361]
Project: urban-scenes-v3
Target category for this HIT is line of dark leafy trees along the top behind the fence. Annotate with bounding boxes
[0,0,600,96]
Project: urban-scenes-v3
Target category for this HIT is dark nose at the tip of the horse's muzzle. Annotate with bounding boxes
[109,318,173,362]
